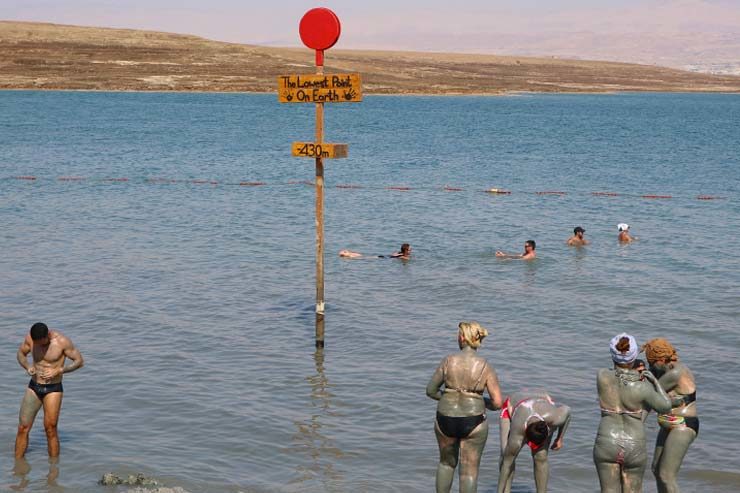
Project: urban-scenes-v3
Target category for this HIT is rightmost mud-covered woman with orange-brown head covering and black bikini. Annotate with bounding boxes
[642,338,699,493]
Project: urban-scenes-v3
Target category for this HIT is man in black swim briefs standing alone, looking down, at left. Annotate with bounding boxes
[15,322,84,459]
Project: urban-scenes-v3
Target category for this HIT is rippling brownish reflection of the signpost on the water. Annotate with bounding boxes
[291,348,343,491]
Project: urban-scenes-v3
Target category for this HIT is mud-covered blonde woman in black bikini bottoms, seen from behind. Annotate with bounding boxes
[427,322,501,493]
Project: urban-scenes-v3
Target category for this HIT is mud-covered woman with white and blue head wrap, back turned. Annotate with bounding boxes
[593,333,671,493]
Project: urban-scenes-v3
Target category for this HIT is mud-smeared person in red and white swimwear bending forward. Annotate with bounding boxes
[498,393,570,493]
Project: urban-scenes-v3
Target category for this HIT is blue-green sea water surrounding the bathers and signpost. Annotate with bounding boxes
[0,92,740,492]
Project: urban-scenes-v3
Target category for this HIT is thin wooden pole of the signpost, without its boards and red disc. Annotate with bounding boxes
[316,62,324,348]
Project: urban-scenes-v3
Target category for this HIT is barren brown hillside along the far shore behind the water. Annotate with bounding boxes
[0,21,740,94]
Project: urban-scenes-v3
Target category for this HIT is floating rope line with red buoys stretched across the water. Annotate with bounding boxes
[3,175,727,201]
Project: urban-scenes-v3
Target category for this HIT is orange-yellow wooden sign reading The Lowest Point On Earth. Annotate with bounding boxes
[278,74,362,103]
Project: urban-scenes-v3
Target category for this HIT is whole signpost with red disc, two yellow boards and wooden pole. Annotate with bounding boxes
[278,7,362,348]
